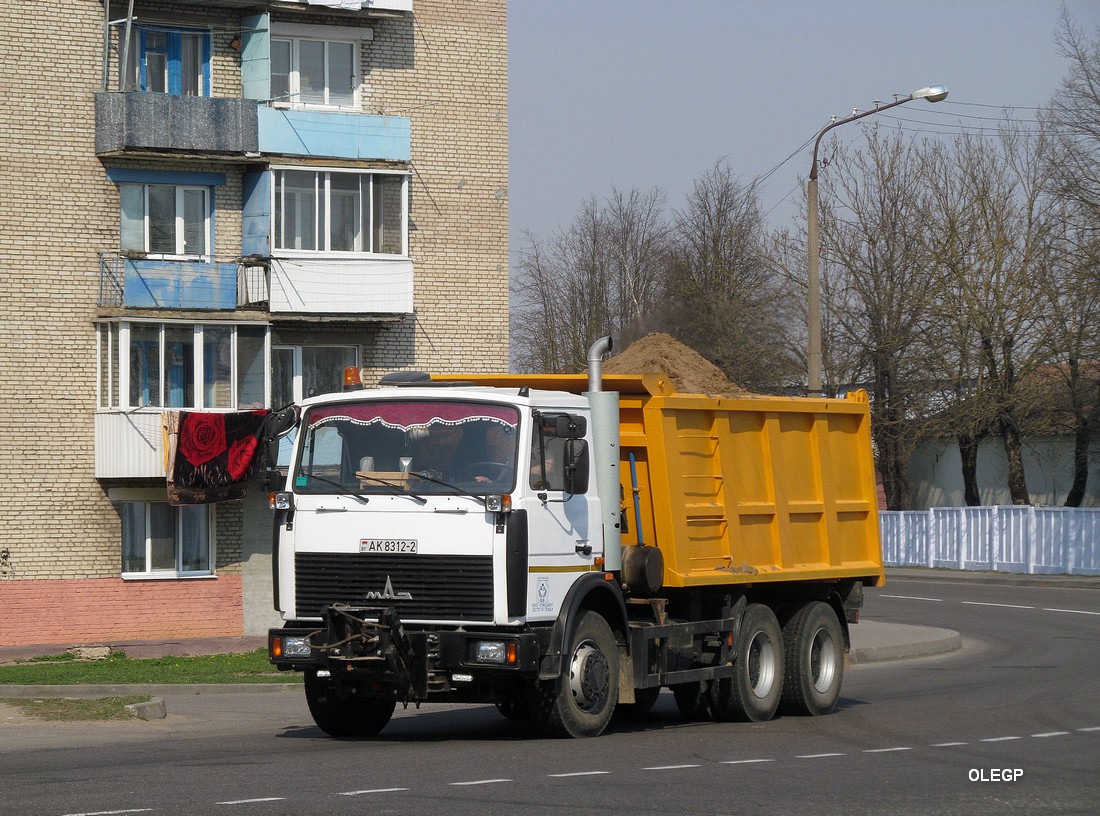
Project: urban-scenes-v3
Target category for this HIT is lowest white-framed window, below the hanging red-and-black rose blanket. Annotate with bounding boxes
[119,501,213,576]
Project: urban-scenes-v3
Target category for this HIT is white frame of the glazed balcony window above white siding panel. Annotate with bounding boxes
[270,165,409,258]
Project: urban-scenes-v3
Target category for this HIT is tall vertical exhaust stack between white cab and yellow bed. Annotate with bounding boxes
[585,337,623,572]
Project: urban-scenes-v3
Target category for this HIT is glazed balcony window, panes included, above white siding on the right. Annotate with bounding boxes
[272,169,407,255]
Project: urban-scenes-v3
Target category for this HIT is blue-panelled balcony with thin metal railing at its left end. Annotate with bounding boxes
[99,252,238,309]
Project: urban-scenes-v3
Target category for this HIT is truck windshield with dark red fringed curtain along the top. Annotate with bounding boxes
[294,399,519,495]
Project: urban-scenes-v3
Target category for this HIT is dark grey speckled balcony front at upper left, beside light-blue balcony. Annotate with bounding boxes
[96,91,260,157]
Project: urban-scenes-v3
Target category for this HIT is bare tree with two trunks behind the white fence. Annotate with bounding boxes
[928,128,1056,504]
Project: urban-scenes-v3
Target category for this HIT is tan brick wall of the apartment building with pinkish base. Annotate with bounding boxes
[0,0,508,642]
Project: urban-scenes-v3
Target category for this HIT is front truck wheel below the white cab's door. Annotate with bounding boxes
[532,610,619,738]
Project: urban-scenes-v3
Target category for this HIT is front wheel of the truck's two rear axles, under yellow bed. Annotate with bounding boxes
[710,604,784,723]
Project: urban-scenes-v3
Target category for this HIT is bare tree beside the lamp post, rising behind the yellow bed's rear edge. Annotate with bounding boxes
[822,128,931,509]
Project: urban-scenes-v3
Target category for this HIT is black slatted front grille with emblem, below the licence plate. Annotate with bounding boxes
[295,552,493,620]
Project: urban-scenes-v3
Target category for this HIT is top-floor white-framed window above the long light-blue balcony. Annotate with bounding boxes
[271,37,359,108]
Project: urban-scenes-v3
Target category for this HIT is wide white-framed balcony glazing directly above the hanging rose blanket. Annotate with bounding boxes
[100,321,267,409]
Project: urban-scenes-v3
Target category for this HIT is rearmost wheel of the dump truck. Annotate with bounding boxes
[780,600,844,717]
